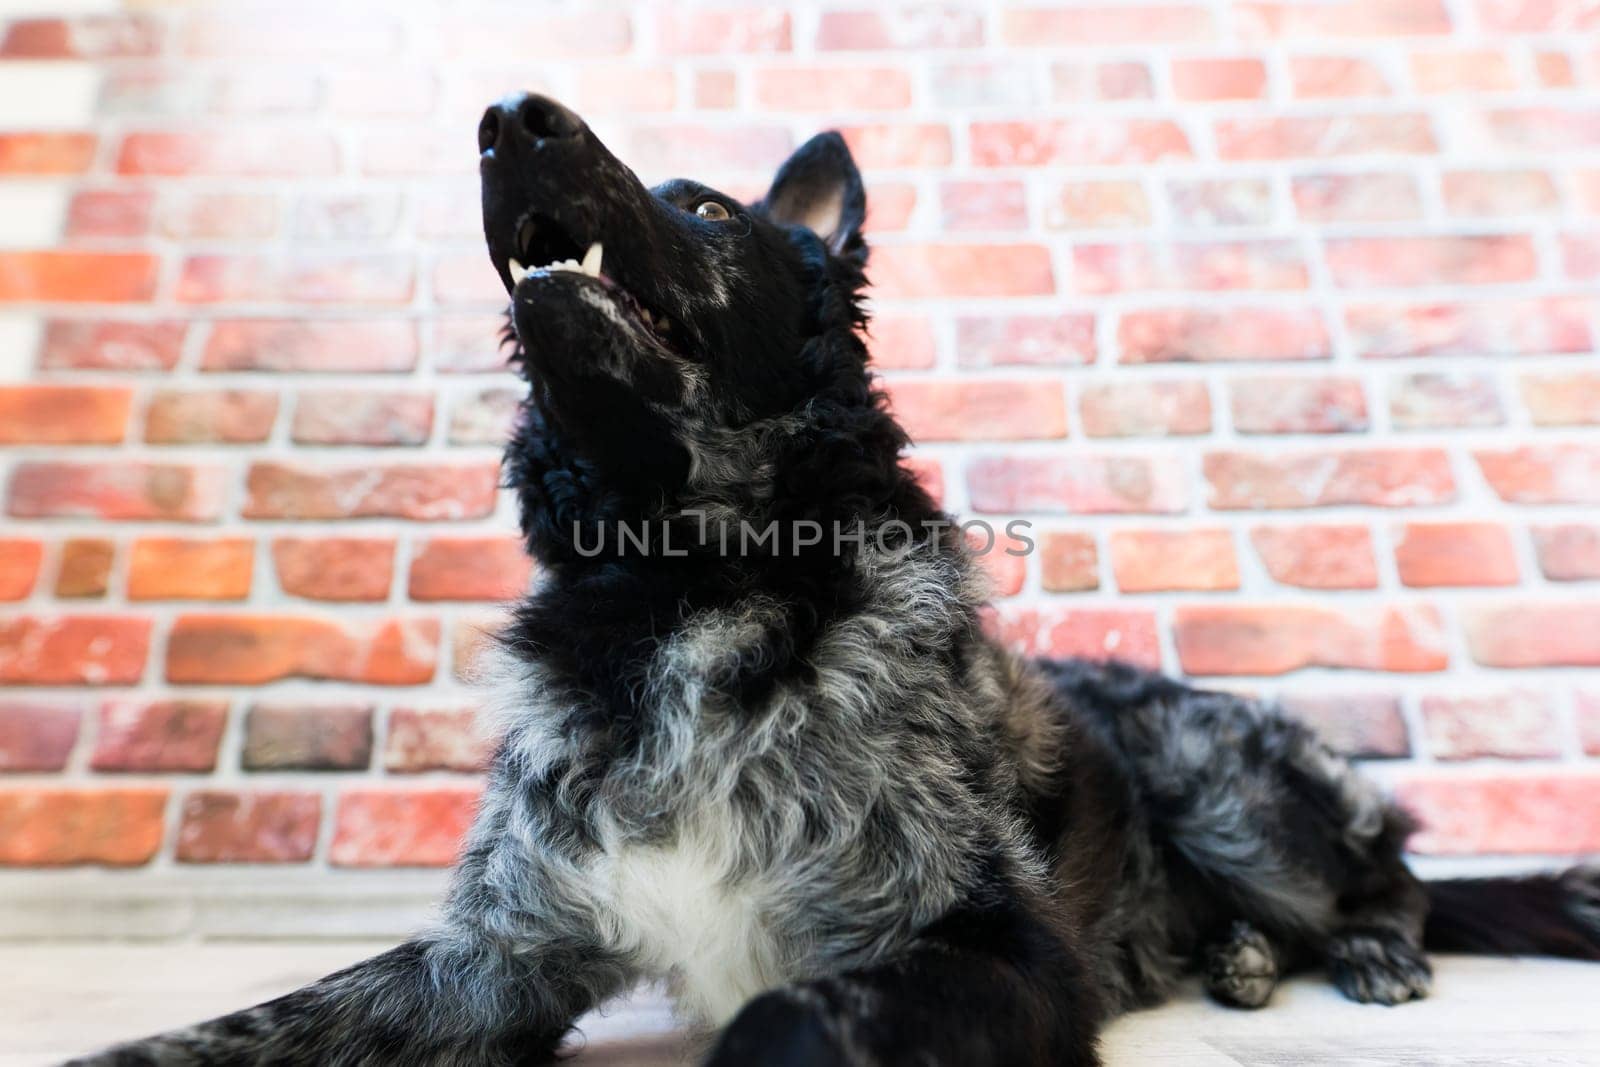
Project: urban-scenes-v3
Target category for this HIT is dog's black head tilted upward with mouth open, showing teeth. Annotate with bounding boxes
[478,96,928,566]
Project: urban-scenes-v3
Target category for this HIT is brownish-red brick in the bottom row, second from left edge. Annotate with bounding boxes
[178,789,322,864]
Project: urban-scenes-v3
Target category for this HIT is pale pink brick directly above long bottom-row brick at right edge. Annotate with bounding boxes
[1422,689,1562,760]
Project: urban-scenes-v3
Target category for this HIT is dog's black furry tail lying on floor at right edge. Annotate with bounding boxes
[1422,865,1600,960]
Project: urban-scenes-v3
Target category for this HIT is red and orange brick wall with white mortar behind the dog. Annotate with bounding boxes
[0,0,1600,889]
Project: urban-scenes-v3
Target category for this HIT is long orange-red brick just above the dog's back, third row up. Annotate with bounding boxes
[1173,605,1450,675]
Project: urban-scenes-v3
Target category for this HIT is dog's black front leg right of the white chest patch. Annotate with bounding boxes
[707,905,1104,1067]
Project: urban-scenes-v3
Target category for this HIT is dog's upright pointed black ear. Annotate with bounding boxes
[757,130,867,262]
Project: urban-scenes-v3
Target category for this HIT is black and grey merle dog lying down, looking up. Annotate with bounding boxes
[80,96,1600,1067]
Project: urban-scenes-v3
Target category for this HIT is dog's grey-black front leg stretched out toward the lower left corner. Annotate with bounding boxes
[62,941,562,1067]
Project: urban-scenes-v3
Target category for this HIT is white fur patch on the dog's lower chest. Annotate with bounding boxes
[595,840,784,1025]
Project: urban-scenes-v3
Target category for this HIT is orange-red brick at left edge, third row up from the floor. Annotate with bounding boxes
[0,614,150,685]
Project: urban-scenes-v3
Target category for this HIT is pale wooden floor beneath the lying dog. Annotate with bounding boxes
[0,942,1600,1067]
